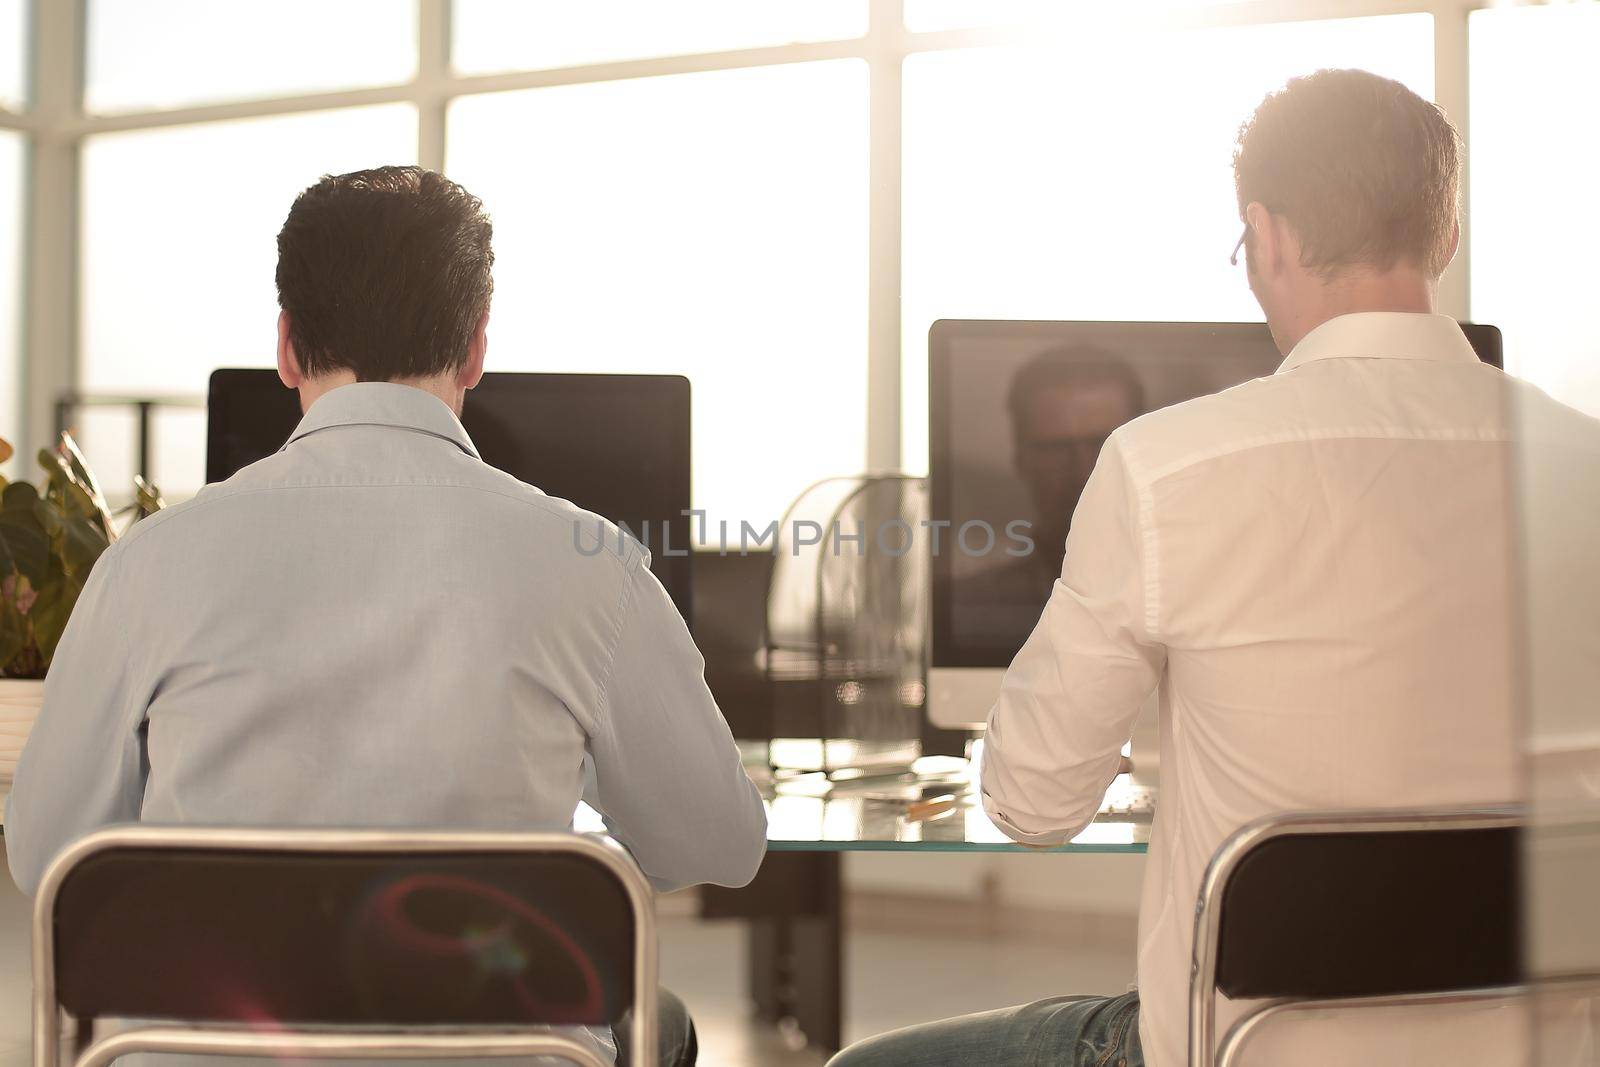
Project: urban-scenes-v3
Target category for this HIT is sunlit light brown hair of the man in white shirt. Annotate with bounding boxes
[1234,70,1461,277]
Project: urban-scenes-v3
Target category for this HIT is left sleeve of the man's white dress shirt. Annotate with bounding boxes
[979,435,1166,846]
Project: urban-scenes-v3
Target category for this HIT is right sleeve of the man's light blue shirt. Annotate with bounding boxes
[587,557,766,889]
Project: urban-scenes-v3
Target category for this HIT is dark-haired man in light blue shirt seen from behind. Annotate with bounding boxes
[5,168,766,1064]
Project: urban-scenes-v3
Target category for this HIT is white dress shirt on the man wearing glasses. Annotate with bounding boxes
[981,314,1590,1067]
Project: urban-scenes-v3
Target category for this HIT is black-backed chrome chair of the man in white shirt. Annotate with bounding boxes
[1189,808,1525,1067]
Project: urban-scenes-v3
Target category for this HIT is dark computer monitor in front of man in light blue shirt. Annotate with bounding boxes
[205,370,693,621]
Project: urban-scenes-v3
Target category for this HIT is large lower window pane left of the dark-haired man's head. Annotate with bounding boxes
[78,104,416,496]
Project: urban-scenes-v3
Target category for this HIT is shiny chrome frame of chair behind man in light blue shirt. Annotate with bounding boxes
[34,825,658,1067]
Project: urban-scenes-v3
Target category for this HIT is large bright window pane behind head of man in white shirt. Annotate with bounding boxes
[901,5,1434,470]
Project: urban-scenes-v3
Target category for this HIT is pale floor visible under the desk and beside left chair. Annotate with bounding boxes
[0,846,1133,1067]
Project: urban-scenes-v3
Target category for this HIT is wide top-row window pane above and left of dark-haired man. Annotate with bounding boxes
[84,0,416,114]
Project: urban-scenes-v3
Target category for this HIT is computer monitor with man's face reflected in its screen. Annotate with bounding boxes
[928,320,1501,729]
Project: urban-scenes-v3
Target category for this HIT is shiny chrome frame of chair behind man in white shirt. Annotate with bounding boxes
[1189,806,1526,1067]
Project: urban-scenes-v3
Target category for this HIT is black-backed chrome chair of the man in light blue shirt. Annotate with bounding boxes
[34,825,656,1067]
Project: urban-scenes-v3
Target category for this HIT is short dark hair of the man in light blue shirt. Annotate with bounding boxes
[277,166,494,382]
